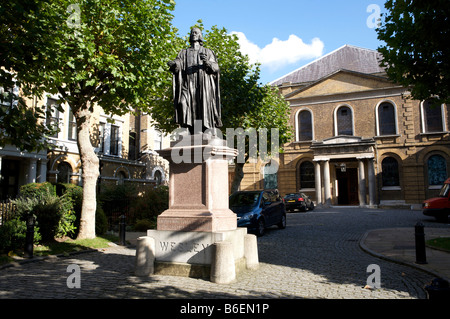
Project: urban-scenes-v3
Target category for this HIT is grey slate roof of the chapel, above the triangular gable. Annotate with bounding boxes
[270,45,384,86]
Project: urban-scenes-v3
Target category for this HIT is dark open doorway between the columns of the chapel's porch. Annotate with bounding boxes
[336,168,359,205]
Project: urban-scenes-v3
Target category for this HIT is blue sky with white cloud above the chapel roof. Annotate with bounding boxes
[173,0,385,83]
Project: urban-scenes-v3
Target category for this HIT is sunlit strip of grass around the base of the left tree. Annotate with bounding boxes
[0,235,118,265]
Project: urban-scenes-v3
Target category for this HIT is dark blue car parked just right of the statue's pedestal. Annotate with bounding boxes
[229,190,286,236]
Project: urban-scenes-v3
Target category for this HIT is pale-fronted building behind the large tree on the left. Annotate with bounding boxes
[0,92,170,200]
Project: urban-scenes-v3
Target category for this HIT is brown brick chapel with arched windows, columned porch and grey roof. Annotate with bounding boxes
[241,45,450,207]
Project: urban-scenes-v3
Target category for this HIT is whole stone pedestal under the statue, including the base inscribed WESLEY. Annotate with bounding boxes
[136,134,258,284]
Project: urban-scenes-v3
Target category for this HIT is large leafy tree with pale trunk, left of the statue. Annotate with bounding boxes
[0,0,175,238]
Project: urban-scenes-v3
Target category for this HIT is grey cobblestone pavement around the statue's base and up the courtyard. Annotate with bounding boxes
[0,208,449,299]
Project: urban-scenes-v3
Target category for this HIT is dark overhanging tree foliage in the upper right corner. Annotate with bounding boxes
[377,0,450,103]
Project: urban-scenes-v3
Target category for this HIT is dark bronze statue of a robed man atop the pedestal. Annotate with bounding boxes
[168,27,222,134]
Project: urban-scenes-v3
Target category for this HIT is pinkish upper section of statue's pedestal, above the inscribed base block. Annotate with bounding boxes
[157,134,237,232]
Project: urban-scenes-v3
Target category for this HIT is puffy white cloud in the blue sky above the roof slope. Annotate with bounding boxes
[231,31,324,71]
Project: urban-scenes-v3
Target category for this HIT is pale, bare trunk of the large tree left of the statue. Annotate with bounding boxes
[74,107,99,239]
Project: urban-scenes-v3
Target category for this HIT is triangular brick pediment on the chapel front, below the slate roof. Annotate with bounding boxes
[286,70,393,100]
